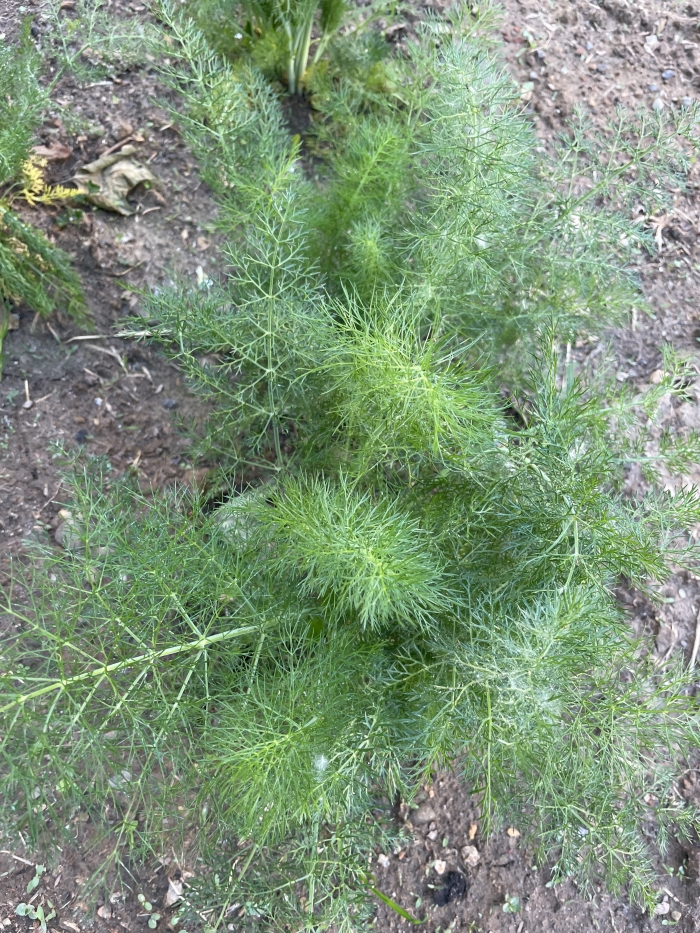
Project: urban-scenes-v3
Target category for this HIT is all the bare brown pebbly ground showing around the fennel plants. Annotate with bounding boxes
[0,0,700,933]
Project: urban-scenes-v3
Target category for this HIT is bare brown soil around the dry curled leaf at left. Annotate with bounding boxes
[0,18,217,574]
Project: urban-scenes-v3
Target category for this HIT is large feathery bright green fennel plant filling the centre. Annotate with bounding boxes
[0,3,700,933]
